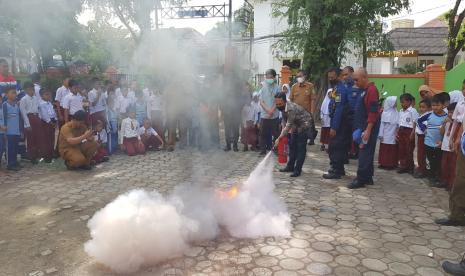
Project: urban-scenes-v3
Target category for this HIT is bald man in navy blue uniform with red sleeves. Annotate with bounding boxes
[348,68,380,189]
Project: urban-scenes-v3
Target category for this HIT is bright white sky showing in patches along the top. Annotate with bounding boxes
[78,0,465,34]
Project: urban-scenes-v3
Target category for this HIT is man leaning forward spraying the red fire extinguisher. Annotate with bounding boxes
[274,92,314,177]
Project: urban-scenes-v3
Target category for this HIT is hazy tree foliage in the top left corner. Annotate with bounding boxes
[0,0,83,72]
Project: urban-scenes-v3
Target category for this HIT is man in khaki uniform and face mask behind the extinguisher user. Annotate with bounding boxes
[289,70,316,145]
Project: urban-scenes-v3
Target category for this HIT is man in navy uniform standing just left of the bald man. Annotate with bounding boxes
[323,68,352,179]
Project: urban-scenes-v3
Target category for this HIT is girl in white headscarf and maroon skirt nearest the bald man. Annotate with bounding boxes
[378,96,399,170]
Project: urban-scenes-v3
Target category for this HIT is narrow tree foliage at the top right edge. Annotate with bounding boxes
[445,0,465,70]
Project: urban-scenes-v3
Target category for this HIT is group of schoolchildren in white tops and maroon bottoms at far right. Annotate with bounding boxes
[378,88,465,190]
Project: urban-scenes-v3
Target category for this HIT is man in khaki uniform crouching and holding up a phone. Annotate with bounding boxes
[58,110,98,170]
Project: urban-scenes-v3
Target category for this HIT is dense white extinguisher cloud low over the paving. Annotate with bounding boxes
[84,154,291,273]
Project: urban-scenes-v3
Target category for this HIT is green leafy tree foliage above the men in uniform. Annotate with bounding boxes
[273,0,409,84]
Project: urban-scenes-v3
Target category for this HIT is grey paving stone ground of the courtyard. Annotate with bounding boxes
[0,146,465,276]
